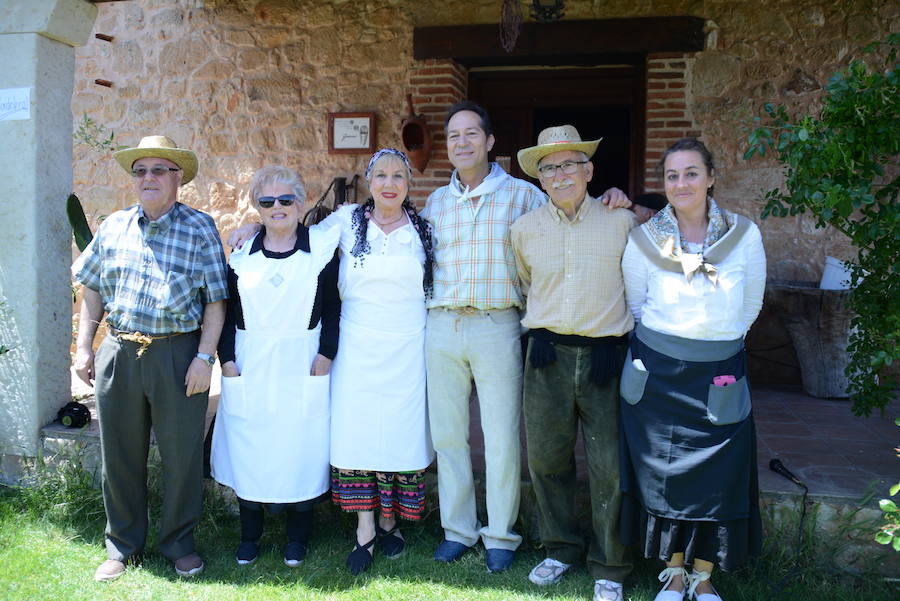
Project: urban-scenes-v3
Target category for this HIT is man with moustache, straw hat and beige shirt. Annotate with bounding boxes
[510,125,635,601]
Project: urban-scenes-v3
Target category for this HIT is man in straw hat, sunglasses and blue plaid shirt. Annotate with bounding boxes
[72,136,228,581]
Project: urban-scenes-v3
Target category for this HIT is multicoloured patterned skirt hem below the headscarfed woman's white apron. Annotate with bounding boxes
[331,467,425,521]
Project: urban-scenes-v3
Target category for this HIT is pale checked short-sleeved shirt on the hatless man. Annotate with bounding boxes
[422,165,547,310]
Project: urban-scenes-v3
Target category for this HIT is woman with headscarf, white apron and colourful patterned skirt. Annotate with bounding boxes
[322,148,434,574]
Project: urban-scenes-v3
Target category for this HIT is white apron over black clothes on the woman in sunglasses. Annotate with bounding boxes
[211,232,334,503]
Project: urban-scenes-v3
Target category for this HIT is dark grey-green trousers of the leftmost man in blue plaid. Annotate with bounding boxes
[94,331,209,561]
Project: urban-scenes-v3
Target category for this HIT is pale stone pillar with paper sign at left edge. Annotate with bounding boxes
[0,0,97,480]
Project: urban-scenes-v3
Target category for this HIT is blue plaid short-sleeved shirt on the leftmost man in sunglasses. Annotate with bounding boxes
[72,202,228,334]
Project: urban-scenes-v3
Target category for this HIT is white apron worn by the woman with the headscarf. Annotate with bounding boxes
[331,223,434,472]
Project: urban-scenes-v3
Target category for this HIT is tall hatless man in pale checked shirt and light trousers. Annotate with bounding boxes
[422,101,630,572]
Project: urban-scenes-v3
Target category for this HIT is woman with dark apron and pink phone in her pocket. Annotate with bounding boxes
[620,139,766,601]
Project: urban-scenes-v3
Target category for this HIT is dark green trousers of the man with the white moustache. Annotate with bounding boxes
[523,340,632,583]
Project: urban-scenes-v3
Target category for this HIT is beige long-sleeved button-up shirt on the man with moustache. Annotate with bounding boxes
[511,196,635,338]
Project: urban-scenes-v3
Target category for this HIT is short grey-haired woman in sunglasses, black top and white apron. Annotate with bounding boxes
[211,166,341,567]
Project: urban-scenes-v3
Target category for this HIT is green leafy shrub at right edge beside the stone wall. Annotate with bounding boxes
[744,34,900,415]
